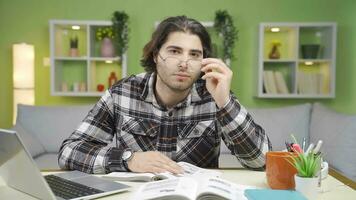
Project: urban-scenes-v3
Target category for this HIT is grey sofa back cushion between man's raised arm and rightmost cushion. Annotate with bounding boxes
[248,103,311,151]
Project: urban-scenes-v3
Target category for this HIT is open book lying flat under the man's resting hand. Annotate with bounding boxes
[102,162,221,182]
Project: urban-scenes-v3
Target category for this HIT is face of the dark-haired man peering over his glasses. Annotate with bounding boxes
[155,32,203,92]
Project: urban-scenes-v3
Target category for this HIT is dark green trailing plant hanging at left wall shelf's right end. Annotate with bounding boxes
[111,11,129,56]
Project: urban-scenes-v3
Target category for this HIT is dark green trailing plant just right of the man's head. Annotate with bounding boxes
[214,10,238,60]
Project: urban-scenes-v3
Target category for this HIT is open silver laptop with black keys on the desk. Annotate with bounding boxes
[0,129,130,200]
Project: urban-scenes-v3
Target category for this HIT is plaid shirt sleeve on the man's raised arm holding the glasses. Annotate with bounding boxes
[217,94,272,170]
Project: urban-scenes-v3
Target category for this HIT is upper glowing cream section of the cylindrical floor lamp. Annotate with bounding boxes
[12,43,35,89]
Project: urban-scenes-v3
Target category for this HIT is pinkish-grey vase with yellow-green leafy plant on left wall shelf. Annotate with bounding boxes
[95,27,114,57]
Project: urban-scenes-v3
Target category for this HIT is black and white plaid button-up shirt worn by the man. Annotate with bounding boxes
[58,73,271,173]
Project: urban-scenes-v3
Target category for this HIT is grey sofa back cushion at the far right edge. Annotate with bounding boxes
[310,103,356,181]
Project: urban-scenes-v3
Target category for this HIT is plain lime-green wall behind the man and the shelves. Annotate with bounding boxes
[0,0,356,128]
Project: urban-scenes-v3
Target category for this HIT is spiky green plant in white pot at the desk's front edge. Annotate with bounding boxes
[289,136,322,199]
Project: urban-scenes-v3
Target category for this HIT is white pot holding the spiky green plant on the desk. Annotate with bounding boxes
[294,174,319,199]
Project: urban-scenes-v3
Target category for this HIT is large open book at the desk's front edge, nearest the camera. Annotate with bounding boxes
[133,177,253,200]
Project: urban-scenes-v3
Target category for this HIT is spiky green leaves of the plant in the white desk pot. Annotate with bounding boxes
[288,135,321,178]
